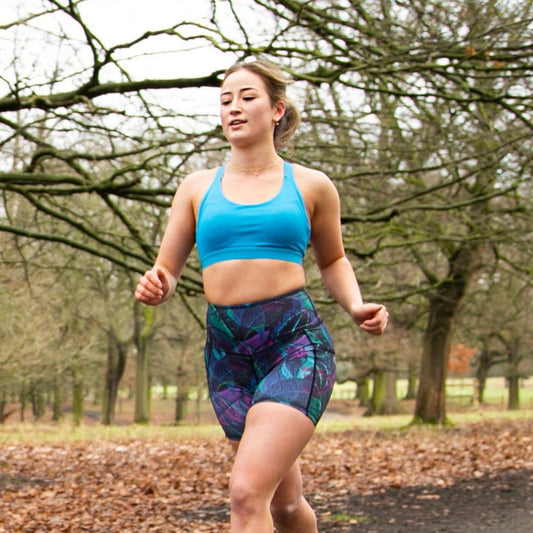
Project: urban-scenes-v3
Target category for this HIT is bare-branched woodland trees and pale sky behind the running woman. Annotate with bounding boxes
[0,0,533,425]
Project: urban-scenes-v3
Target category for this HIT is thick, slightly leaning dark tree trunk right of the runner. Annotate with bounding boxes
[414,243,481,424]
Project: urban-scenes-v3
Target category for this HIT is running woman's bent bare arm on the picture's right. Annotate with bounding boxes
[311,168,389,335]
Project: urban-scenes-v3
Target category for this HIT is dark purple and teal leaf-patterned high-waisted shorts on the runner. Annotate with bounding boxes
[205,289,335,440]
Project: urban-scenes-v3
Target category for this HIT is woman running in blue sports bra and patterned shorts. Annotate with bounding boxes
[135,60,388,533]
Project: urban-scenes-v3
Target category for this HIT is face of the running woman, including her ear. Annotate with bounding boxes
[220,68,284,146]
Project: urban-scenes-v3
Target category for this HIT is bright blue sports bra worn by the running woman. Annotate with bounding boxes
[196,161,311,268]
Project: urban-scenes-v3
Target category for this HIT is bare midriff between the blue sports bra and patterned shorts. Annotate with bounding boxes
[203,259,305,305]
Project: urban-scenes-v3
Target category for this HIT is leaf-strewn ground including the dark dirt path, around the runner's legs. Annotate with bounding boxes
[0,406,533,533]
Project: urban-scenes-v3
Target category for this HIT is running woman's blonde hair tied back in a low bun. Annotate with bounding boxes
[223,59,300,149]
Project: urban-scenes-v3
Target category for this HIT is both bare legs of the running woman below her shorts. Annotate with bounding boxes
[230,402,316,533]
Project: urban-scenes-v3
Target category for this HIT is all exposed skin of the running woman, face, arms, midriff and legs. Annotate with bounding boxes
[135,64,388,533]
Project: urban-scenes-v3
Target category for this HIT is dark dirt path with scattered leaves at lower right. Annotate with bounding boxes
[319,469,533,533]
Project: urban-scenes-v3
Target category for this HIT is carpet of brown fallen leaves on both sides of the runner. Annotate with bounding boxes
[0,420,533,533]
